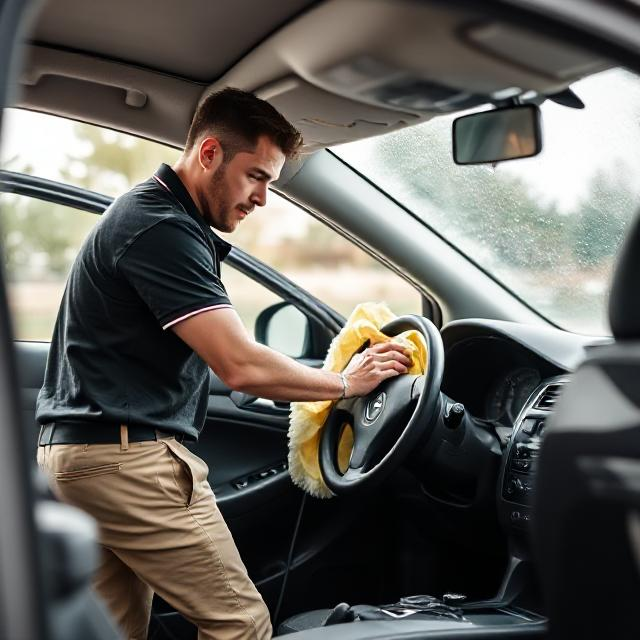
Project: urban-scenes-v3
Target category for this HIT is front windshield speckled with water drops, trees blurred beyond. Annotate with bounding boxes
[333,69,640,335]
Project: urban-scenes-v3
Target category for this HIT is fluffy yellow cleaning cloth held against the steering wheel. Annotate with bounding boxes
[289,302,427,498]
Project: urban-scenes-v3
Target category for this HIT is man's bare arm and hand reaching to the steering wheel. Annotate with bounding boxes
[171,308,411,401]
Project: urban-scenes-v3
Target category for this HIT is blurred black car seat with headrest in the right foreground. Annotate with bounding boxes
[534,211,640,640]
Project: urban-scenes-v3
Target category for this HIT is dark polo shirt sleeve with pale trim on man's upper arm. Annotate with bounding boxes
[117,220,231,329]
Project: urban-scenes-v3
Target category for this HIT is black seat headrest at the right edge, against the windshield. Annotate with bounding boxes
[609,215,640,340]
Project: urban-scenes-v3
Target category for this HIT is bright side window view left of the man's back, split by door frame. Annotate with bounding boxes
[0,109,185,341]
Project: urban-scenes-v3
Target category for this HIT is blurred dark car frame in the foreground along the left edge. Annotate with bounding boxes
[0,0,119,640]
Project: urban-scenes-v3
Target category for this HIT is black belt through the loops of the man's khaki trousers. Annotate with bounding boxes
[38,422,184,447]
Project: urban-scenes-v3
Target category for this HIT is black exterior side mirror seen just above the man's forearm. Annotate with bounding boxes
[256,302,311,358]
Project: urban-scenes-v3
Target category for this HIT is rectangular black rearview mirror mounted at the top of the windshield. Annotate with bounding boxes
[453,104,542,164]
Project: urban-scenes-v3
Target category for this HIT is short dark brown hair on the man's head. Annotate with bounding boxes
[185,87,302,162]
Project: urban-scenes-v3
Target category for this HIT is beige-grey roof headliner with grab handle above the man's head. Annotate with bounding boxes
[15,0,609,151]
